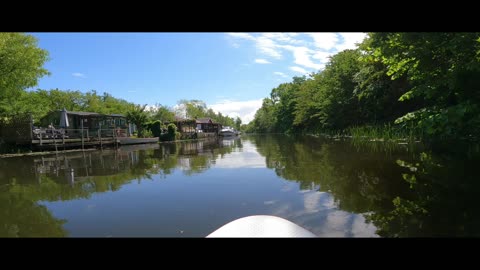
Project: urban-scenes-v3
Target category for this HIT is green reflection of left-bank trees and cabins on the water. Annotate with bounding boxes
[0,140,240,237]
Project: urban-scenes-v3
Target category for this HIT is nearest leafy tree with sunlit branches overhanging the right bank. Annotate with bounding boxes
[365,32,480,138]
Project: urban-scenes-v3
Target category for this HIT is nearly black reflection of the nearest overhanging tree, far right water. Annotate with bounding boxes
[370,152,480,237]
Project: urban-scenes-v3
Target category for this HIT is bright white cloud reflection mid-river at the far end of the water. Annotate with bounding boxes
[215,141,266,168]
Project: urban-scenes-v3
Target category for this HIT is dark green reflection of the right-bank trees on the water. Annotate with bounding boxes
[250,136,480,237]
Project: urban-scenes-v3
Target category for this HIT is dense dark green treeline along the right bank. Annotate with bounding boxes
[247,33,480,142]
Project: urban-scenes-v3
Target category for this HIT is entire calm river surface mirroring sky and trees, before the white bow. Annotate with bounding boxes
[0,135,480,237]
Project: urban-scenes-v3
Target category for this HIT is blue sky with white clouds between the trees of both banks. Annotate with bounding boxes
[32,33,365,123]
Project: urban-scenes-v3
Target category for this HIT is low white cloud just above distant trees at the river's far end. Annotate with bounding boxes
[208,99,263,124]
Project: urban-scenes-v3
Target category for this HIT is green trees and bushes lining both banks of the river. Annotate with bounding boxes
[0,32,480,153]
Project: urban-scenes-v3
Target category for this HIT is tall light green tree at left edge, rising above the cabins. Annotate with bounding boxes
[0,33,50,114]
